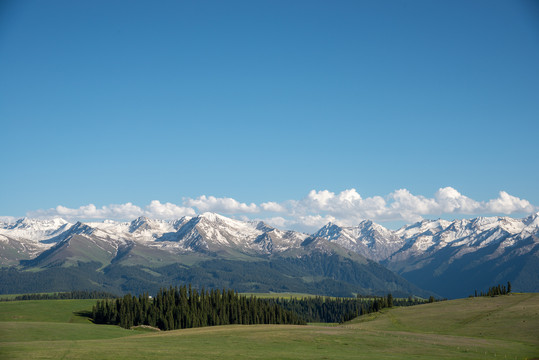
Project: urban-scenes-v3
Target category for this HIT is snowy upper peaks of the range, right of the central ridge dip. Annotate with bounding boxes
[313,213,539,270]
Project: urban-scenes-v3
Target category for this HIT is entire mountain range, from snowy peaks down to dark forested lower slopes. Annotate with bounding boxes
[0,213,539,298]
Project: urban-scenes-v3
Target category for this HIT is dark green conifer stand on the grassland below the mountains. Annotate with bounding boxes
[92,285,432,330]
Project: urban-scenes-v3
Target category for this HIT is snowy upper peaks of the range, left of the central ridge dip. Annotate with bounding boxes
[0,213,314,265]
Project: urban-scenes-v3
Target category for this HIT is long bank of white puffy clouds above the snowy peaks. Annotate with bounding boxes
[27,187,539,230]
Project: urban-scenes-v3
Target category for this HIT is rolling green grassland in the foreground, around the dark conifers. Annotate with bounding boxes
[0,294,539,359]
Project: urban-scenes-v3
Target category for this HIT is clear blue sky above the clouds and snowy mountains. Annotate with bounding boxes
[0,0,539,227]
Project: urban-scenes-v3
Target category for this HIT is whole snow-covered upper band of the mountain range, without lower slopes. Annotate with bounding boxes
[0,212,539,268]
